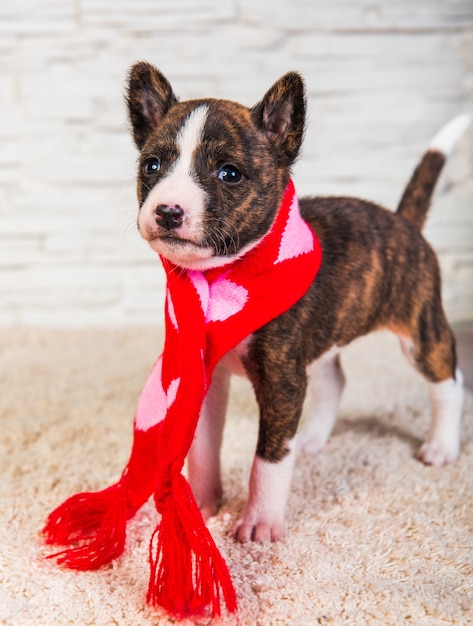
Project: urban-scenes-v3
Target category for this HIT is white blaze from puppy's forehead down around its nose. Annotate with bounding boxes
[139,105,209,242]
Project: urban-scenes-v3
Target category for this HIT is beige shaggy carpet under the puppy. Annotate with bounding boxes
[0,329,473,626]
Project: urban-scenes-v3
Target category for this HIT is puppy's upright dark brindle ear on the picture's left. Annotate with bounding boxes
[126,61,177,150]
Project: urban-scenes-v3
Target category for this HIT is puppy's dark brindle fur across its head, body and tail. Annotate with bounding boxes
[127,63,456,462]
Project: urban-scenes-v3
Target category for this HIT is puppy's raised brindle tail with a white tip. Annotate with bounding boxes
[396,113,472,230]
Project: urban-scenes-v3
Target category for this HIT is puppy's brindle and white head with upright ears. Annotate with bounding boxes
[127,63,305,270]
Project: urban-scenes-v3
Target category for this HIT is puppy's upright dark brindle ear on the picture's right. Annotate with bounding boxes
[251,72,306,166]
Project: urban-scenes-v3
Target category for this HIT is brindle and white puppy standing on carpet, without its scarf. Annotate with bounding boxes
[127,63,469,542]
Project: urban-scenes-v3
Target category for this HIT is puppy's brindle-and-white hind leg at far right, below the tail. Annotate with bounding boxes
[400,314,464,466]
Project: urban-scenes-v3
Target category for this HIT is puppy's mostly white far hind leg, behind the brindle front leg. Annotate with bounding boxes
[298,348,345,454]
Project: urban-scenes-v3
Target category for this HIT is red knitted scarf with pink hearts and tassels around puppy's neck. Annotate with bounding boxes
[44,181,321,618]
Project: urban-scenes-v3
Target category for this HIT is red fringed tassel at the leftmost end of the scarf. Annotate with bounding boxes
[43,483,128,570]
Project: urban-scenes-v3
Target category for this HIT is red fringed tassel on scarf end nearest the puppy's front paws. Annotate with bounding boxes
[147,474,237,619]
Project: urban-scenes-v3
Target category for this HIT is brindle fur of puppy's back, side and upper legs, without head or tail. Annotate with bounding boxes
[245,193,456,461]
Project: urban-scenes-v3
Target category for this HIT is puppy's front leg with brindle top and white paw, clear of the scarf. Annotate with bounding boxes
[232,345,307,542]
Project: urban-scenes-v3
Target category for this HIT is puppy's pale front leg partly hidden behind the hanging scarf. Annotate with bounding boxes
[187,365,230,519]
